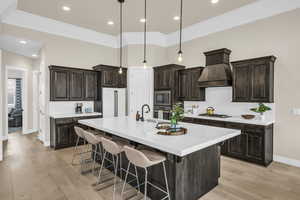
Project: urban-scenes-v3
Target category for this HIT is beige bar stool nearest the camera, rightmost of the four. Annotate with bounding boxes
[121,146,170,200]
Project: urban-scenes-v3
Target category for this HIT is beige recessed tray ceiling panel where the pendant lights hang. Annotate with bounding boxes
[17,0,257,35]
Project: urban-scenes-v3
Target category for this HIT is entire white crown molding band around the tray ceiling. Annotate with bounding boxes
[0,0,300,48]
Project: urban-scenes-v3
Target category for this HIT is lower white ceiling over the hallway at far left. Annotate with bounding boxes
[0,35,43,59]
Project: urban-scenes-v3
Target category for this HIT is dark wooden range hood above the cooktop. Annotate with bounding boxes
[198,48,232,87]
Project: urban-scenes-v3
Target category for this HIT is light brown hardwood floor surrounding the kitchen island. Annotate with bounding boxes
[0,133,300,200]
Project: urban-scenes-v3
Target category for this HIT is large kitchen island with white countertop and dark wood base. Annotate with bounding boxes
[79,117,241,200]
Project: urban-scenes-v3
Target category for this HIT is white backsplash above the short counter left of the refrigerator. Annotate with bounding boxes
[49,101,94,114]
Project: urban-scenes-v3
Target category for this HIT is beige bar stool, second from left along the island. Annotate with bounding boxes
[83,130,104,174]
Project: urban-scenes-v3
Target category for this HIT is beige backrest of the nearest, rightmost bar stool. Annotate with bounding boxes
[124,146,152,168]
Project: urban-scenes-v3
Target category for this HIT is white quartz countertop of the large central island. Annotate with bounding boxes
[79,117,241,157]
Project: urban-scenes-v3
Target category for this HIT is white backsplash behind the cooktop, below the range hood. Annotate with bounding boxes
[184,87,275,119]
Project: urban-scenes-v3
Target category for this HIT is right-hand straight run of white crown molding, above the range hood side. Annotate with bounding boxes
[167,0,300,46]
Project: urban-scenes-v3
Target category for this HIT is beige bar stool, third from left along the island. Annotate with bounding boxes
[97,137,128,200]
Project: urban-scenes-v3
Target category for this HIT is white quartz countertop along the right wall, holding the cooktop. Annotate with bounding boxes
[184,114,275,126]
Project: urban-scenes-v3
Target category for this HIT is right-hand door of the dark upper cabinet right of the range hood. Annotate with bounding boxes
[250,60,270,102]
